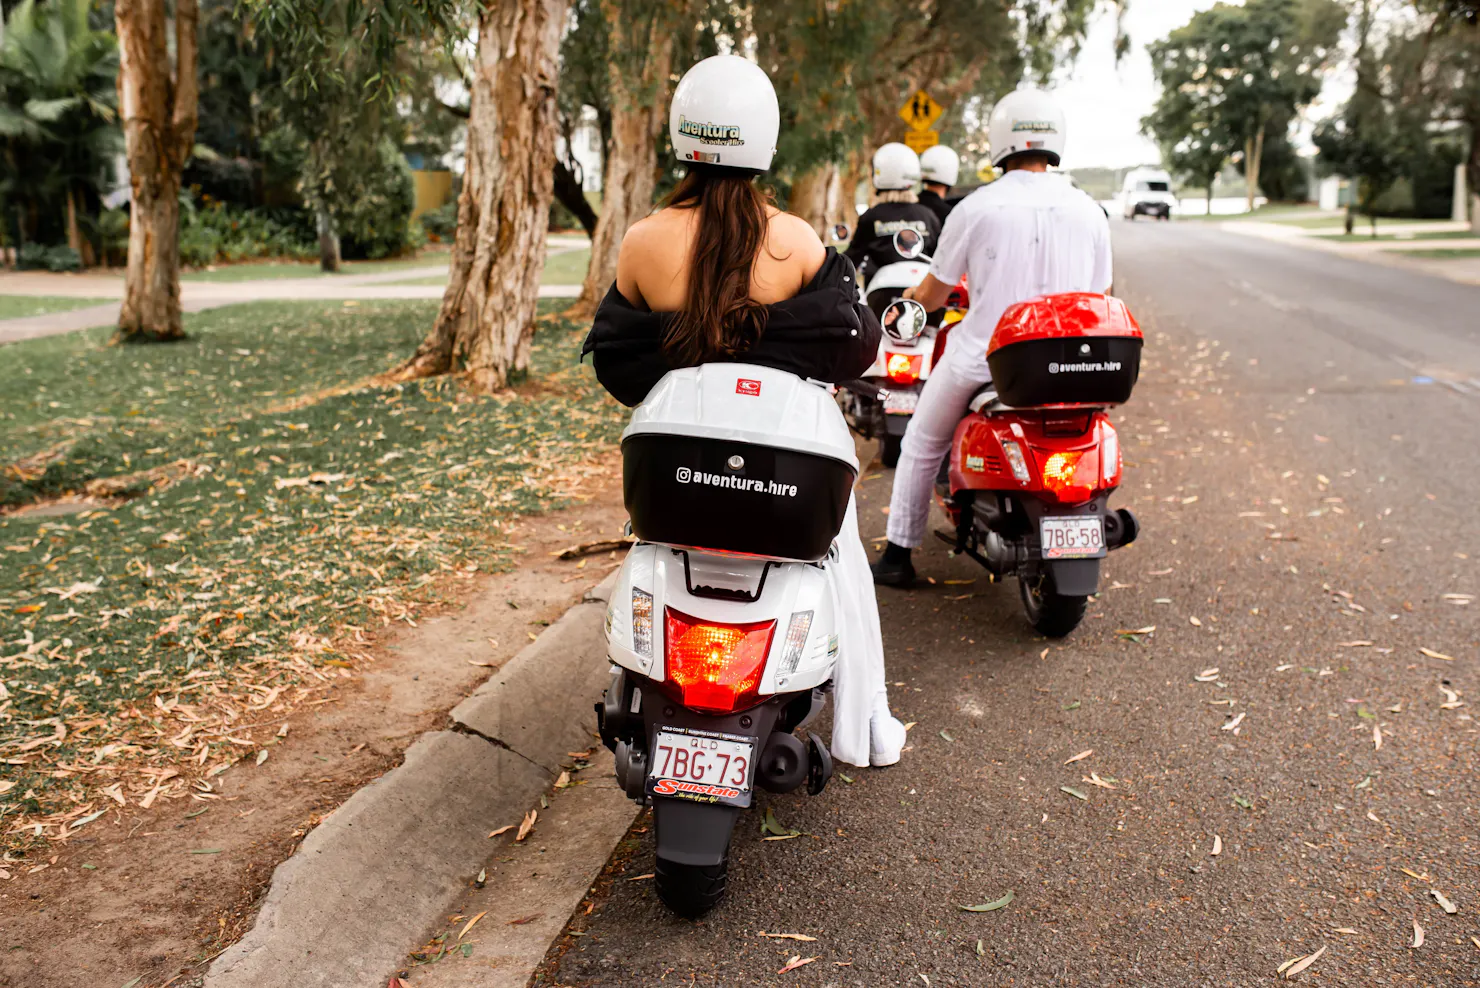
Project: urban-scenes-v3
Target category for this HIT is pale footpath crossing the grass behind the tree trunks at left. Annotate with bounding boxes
[0,257,585,346]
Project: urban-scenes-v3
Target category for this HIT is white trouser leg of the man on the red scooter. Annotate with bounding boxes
[888,348,992,549]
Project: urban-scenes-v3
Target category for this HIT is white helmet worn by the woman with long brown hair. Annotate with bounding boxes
[667,55,781,172]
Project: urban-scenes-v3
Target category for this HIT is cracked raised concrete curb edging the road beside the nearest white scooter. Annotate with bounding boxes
[204,571,617,988]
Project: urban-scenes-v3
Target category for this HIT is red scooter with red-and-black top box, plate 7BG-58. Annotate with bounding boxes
[897,293,1143,637]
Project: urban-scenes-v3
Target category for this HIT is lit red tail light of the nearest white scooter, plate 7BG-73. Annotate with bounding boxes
[663,608,776,713]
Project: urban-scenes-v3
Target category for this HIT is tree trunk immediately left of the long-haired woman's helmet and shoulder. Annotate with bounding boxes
[565,0,673,318]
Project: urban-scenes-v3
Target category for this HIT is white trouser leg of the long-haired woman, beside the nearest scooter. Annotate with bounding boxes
[827,495,903,765]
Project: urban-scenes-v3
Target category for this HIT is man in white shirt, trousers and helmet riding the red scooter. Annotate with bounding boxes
[873,89,1111,587]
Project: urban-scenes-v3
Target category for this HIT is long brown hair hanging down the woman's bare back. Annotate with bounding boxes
[663,164,771,367]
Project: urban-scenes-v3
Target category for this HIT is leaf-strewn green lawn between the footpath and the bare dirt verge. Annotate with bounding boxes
[0,300,626,851]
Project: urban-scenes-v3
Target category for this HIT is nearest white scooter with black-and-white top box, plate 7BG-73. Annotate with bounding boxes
[596,364,858,917]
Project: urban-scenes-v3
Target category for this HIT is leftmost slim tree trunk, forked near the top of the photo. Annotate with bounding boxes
[114,0,200,342]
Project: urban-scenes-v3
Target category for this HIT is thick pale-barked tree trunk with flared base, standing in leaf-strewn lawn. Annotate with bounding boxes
[389,0,565,390]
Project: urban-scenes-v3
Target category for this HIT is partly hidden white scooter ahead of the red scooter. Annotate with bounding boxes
[841,229,935,467]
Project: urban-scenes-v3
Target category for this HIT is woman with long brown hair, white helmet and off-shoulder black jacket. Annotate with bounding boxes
[583,55,904,766]
